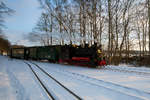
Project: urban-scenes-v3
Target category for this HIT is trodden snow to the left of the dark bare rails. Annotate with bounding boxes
[0,56,48,100]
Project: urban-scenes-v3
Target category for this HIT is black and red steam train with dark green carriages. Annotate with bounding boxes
[10,44,106,67]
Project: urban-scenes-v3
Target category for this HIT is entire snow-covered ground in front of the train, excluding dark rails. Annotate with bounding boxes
[0,56,150,100]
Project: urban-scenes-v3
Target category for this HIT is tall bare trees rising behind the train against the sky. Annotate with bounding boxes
[29,0,150,63]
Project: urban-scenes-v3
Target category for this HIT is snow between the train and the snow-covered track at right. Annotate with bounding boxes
[35,63,150,93]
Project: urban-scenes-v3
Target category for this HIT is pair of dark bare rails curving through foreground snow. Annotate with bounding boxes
[25,62,82,100]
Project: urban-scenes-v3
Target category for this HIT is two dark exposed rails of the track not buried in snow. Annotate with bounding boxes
[24,62,82,100]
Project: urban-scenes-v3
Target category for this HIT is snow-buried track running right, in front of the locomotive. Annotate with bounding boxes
[29,61,150,100]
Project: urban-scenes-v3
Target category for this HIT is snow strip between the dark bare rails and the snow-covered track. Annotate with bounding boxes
[29,64,143,100]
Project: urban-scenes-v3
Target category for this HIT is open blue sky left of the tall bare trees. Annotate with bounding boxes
[0,0,42,46]
